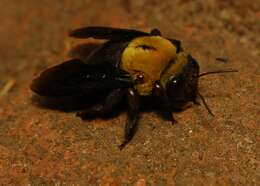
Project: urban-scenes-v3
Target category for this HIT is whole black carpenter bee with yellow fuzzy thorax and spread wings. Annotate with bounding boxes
[31,27,238,149]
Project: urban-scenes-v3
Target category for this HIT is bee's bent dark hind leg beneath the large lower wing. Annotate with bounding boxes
[76,88,124,119]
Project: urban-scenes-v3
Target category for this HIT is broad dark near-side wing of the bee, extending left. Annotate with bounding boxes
[31,59,133,97]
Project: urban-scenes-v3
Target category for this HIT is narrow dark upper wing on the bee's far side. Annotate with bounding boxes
[69,26,150,40]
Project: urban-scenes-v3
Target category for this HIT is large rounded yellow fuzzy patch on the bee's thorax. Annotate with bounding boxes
[121,36,176,96]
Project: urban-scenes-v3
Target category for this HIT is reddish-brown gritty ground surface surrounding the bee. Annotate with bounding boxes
[0,0,260,186]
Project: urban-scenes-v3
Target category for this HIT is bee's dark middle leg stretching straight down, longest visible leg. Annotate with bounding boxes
[119,88,139,150]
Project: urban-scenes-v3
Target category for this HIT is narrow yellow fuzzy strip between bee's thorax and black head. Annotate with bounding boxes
[160,52,188,87]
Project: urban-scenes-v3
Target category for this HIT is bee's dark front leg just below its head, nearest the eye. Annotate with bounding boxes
[153,81,177,124]
